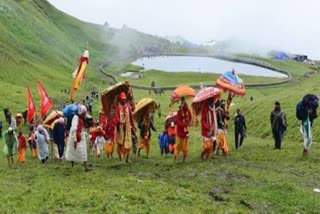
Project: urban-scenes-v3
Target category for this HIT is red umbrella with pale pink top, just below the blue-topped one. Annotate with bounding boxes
[191,87,223,115]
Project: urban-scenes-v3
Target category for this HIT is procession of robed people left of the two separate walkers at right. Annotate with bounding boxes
[3,89,246,171]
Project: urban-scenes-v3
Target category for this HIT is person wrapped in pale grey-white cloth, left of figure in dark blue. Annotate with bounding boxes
[35,125,50,163]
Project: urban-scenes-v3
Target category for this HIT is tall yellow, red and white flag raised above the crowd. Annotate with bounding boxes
[70,50,89,101]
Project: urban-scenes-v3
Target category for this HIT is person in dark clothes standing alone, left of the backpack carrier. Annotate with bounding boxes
[270,101,287,149]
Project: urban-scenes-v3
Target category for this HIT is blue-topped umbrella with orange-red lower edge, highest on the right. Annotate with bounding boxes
[216,71,246,96]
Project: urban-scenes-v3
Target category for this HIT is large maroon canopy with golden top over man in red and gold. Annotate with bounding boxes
[101,81,135,117]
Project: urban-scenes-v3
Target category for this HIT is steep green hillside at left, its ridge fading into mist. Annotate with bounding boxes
[0,0,183,112]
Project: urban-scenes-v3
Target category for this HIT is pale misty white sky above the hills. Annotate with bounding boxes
[49,0,320,59]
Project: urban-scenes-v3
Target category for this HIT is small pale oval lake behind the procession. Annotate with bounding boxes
[132,56,287,78]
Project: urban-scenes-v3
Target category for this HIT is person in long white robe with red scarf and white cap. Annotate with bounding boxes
[65,105,91,171]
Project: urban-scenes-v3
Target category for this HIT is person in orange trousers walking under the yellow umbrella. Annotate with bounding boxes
[138,112,156,158]
